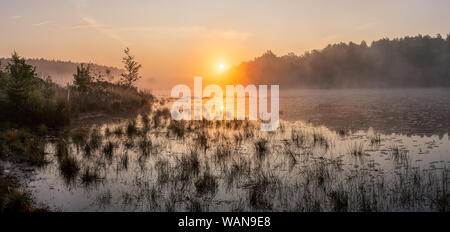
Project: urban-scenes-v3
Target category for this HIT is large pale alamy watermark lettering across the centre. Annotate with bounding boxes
[171,77,280,131]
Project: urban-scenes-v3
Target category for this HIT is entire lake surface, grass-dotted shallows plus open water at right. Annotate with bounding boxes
[15,89,450,211]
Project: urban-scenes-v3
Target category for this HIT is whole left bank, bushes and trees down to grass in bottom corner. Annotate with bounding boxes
[0,50,155,212]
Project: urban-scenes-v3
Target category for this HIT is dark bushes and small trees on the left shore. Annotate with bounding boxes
[0,48,153,129]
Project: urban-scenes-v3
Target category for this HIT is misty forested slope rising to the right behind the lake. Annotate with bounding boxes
[228,34,450,88]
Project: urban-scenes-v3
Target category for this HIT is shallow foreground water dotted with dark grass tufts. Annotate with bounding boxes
[25,117,450,211]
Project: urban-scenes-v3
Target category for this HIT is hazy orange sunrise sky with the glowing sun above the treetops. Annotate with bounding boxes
[0,0,450,87]
